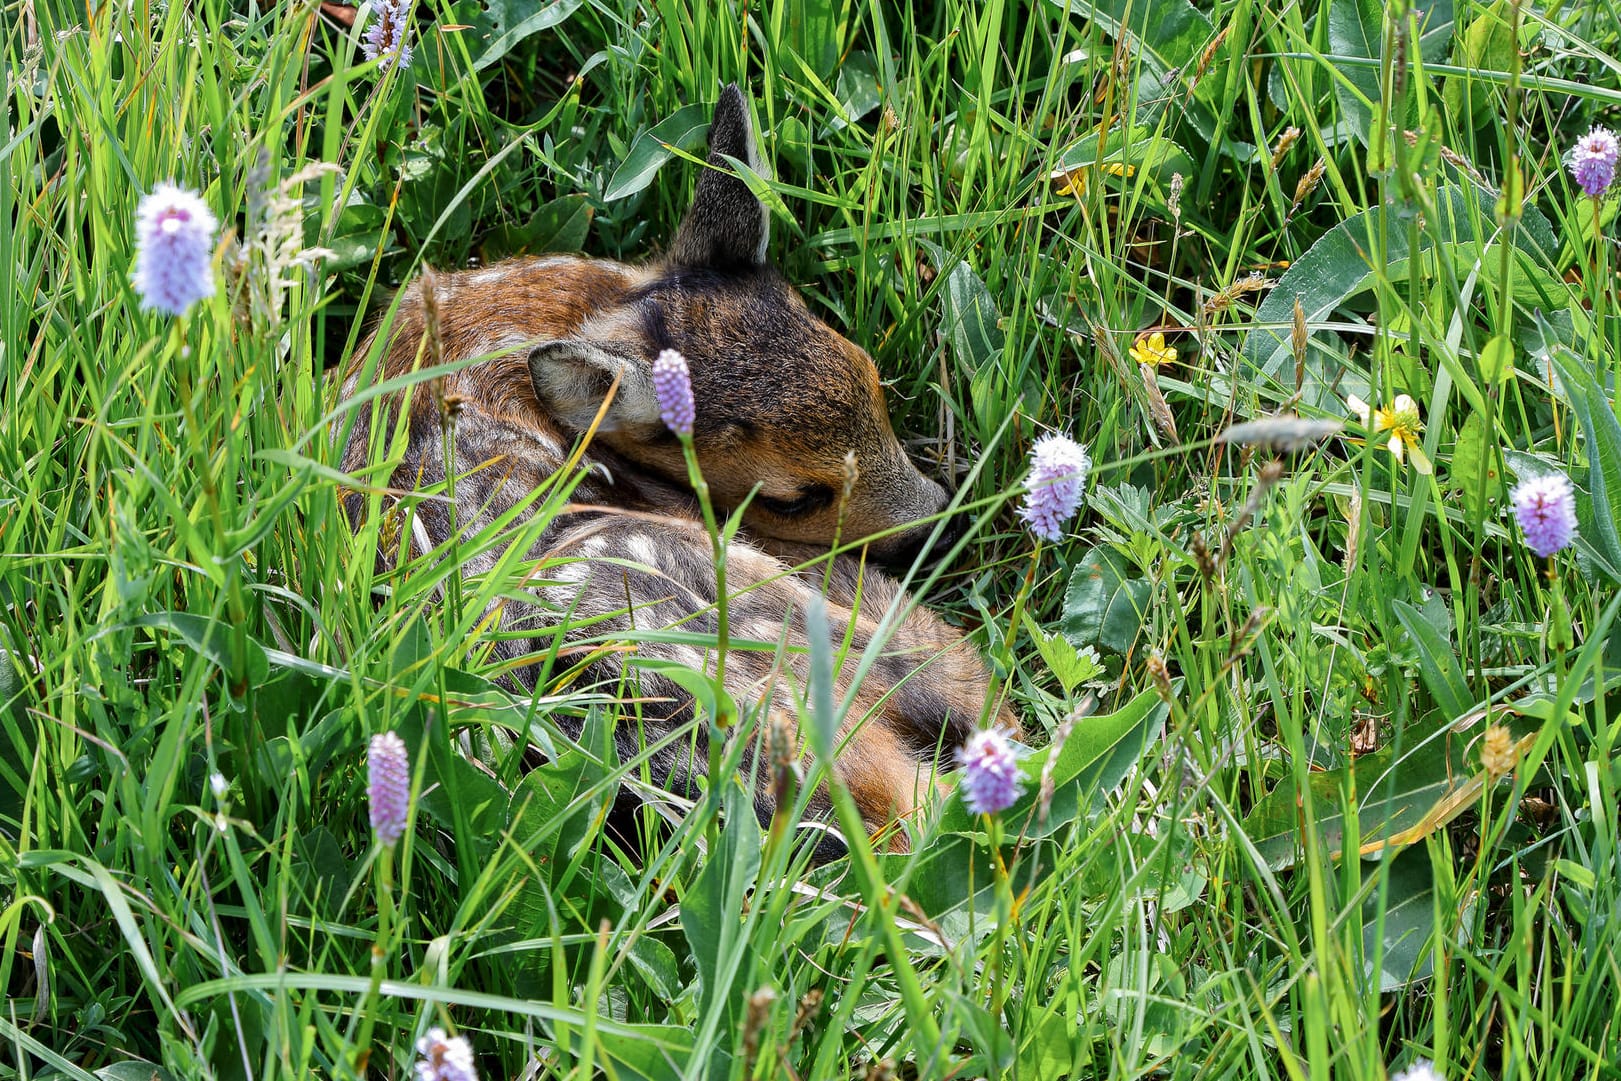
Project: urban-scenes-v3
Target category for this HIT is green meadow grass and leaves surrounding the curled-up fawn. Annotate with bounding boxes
[0,0,1621,1081]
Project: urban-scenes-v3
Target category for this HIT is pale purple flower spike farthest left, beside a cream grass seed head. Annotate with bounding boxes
[131,183,219,316]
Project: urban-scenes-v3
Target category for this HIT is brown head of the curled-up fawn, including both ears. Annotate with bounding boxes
[528,86,945,558]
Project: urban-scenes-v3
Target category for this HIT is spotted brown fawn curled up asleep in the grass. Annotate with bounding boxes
[342,86,1016,844]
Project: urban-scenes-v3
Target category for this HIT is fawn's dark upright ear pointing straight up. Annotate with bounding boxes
[669,83,770,271]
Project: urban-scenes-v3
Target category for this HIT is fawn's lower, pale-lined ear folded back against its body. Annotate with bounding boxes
[528,339,660,433]
